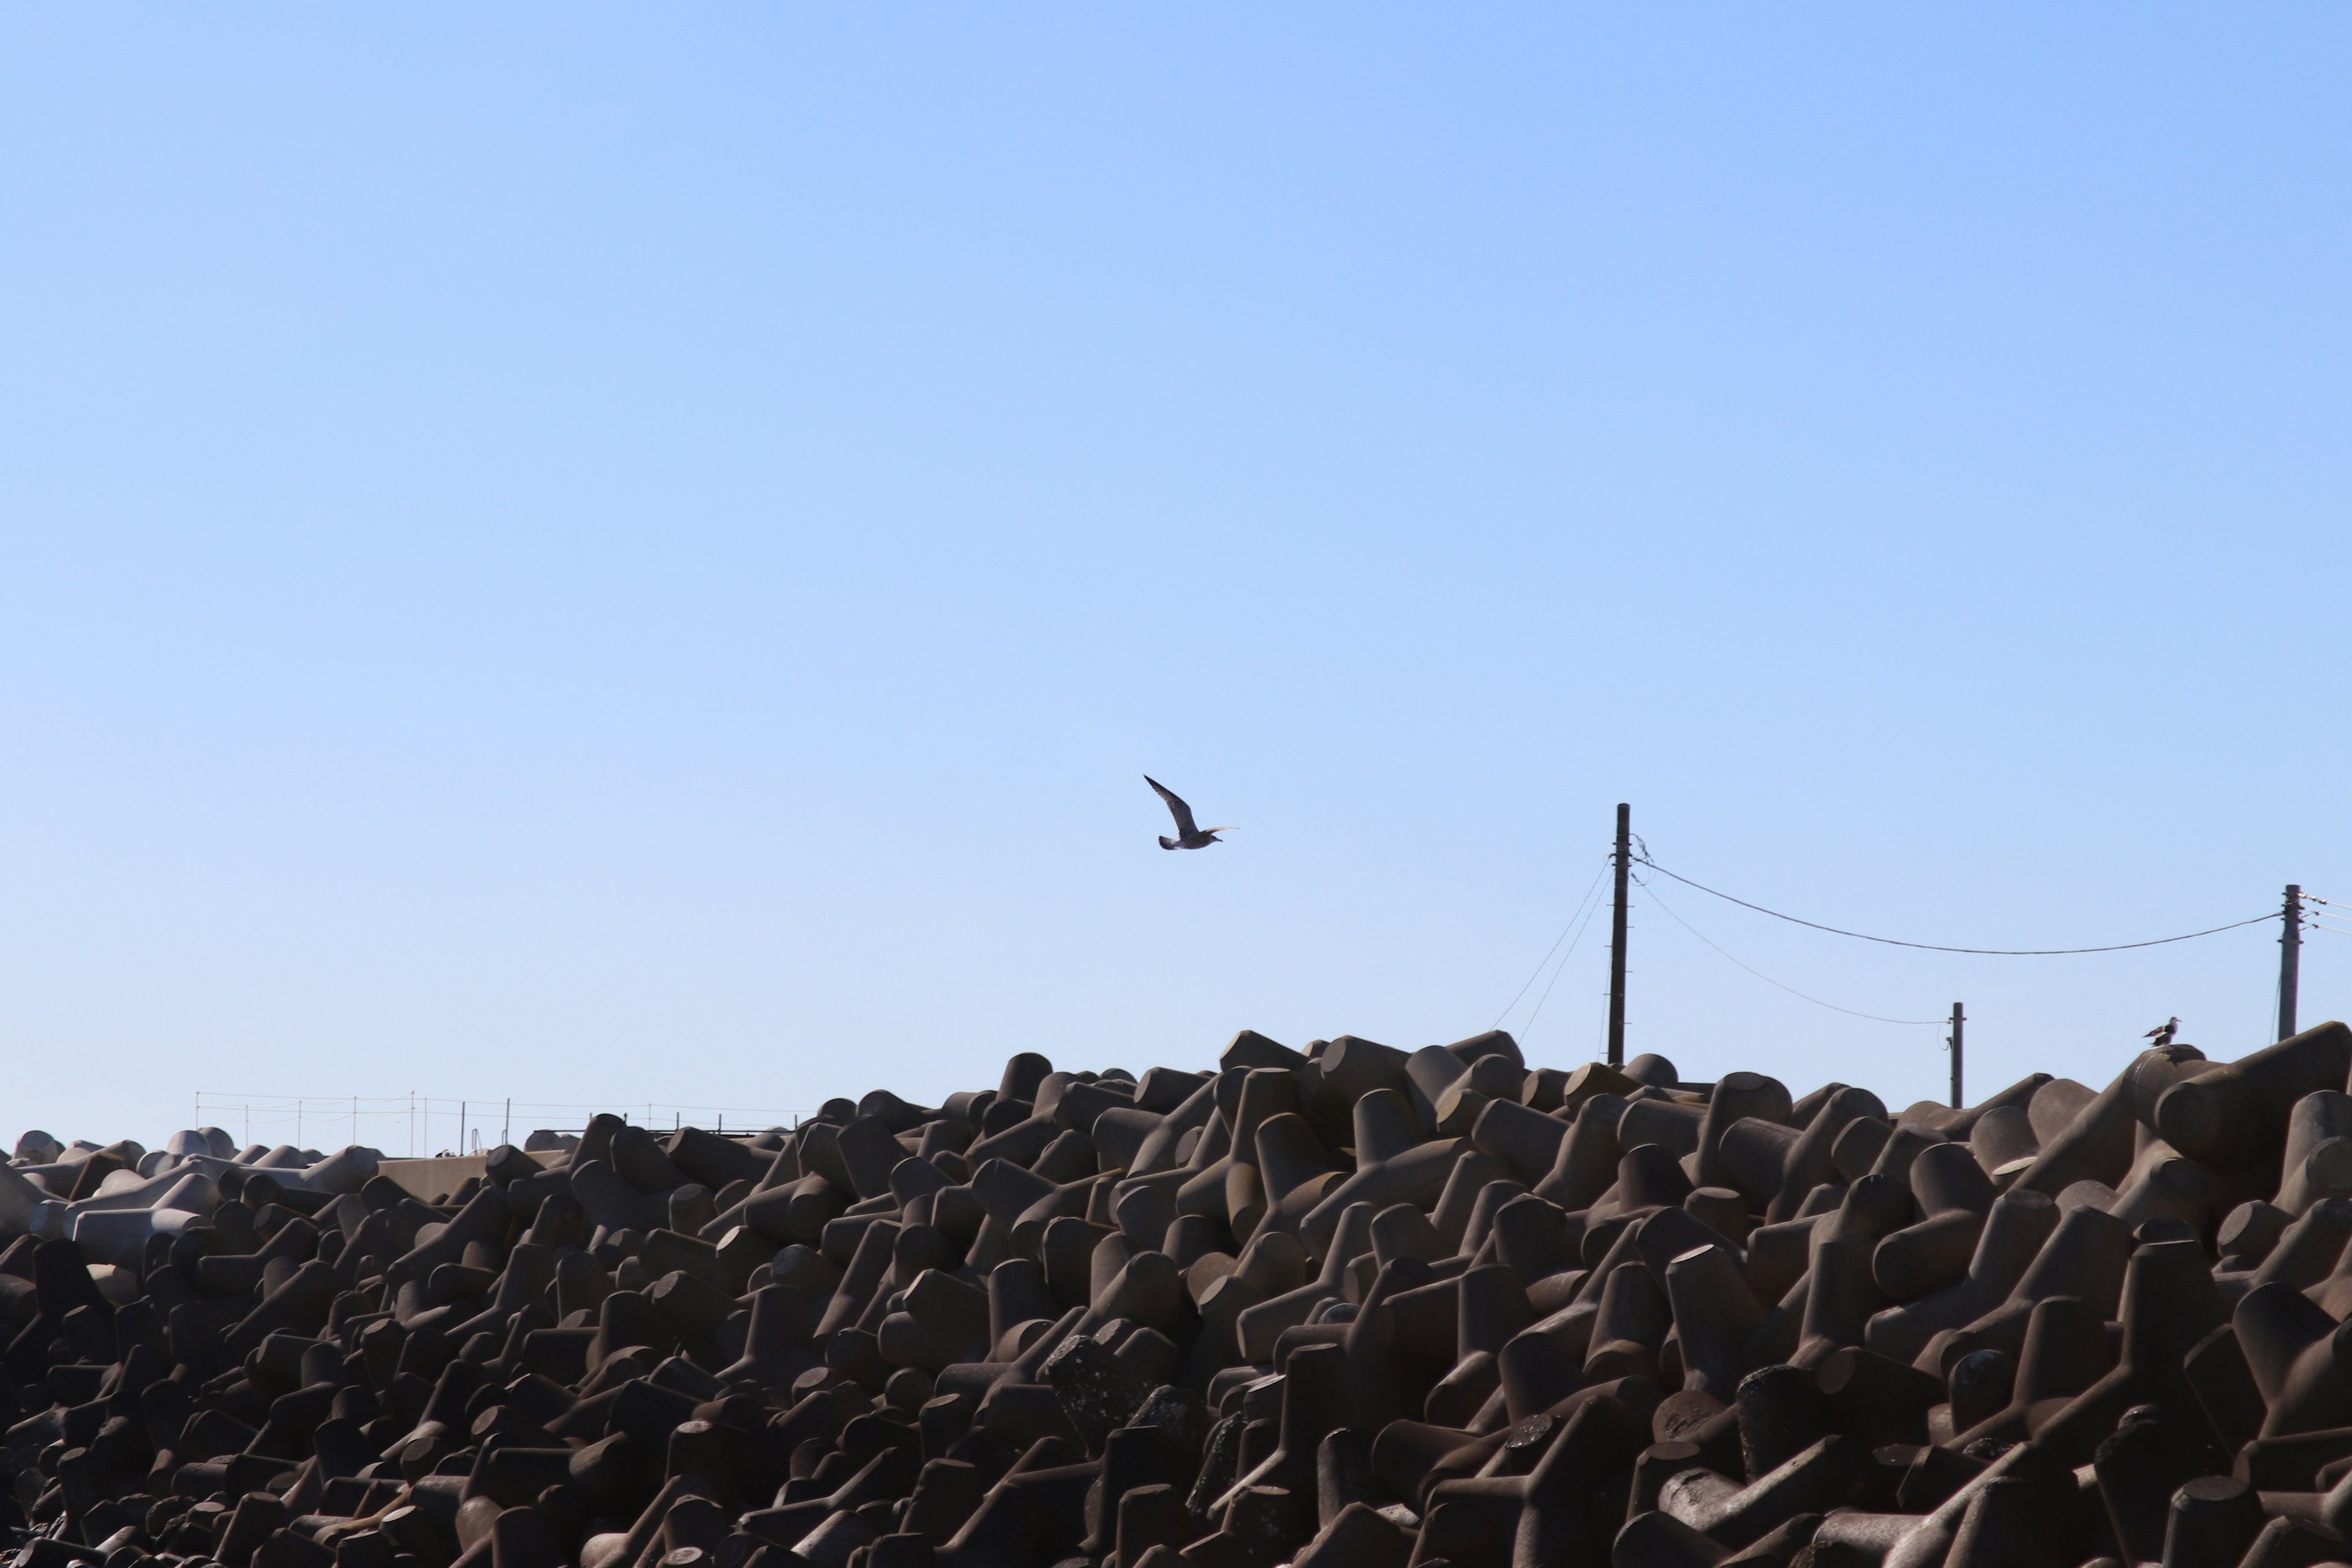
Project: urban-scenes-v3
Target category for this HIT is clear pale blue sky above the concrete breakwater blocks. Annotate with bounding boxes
[0,5,2352,1150]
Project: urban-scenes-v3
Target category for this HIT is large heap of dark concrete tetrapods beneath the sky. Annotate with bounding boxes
[0,1023,2352,1568]
